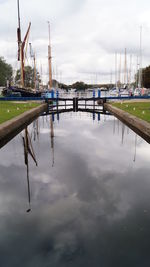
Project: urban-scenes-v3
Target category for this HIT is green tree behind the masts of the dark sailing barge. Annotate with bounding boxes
[15,66,41,88]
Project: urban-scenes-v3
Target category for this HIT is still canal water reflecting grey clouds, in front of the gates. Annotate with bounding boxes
[0,113,150,267]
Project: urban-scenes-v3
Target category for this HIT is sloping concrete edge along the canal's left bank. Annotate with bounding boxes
[0,103,47,148]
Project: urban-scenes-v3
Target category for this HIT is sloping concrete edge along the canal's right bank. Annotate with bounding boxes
[104,103,150,144]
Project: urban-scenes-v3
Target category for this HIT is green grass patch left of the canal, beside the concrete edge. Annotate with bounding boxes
[0,101,40,124]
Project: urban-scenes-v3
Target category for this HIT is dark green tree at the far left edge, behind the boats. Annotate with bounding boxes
[0,57,13,86]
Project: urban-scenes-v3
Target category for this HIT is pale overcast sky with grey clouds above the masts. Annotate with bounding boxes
[0,0,150,84]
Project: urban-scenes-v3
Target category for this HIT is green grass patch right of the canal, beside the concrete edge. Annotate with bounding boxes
[112,102,150,122]
